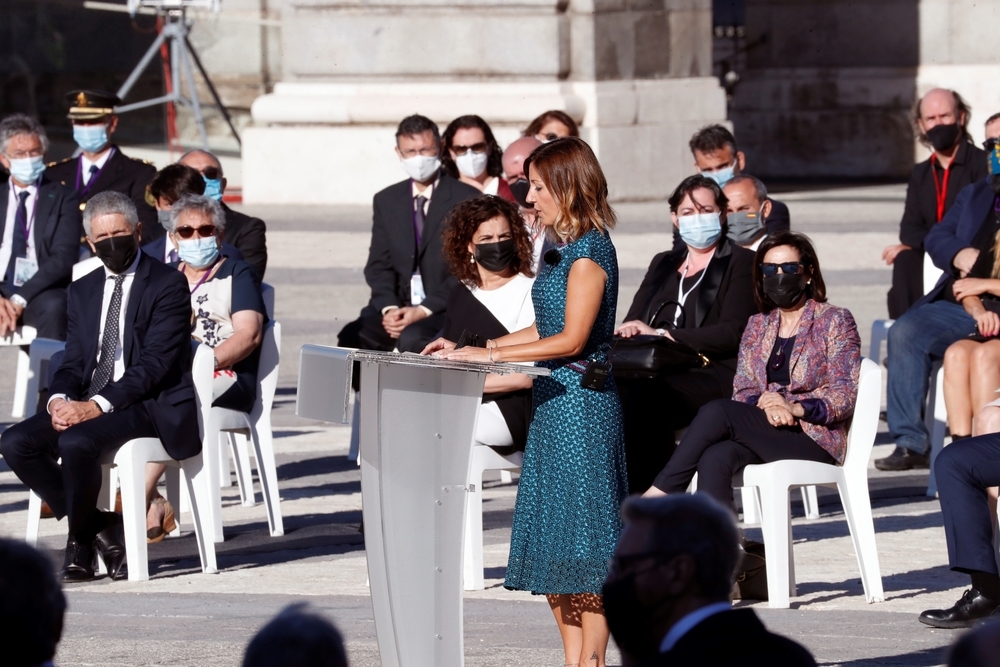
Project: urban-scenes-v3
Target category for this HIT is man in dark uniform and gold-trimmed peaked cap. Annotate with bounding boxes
[45,90,158,242]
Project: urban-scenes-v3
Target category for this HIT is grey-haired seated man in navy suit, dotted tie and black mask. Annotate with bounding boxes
[0,192,201,581]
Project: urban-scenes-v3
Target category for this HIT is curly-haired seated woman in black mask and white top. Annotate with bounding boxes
[425,195,535,455]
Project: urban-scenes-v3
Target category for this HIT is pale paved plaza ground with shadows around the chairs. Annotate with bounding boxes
[0,185,968,667]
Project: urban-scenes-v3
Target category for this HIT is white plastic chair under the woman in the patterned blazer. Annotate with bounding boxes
[734,359,884,609]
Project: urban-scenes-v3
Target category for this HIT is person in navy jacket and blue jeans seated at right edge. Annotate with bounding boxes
[875,117,1000,470]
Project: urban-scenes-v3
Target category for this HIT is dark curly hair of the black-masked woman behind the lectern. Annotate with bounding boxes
[441,195,534,287]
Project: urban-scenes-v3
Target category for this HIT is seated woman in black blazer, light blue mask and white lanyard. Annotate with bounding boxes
[616,175,757,493]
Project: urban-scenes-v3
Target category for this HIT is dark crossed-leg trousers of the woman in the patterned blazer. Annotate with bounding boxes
[654,399,835,507]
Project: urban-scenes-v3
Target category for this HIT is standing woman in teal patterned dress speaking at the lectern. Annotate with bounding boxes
[429,138,627,667]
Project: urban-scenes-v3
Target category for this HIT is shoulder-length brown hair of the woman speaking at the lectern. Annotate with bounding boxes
[524,137,618,241]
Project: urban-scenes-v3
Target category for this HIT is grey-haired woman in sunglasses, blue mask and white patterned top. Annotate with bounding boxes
[146,194,267,542]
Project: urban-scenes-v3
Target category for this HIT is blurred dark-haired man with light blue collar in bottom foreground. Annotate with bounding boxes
[604,493,816,667]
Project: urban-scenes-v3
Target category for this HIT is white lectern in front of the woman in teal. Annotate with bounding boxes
[299,346,549,667]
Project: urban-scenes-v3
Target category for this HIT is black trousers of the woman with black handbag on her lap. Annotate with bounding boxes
[615,368,733,493]
